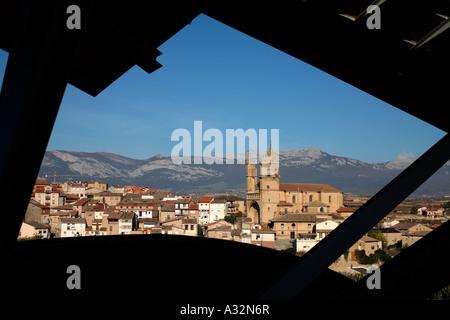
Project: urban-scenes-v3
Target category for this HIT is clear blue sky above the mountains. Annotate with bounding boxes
[0,15,444,162]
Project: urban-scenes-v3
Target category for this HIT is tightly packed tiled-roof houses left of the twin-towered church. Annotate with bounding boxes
[19,179,245,238]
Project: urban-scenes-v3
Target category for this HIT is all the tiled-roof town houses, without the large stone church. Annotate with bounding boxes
[19,179,446,258]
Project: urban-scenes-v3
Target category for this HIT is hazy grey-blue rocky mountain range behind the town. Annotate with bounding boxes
[39,147,450,196]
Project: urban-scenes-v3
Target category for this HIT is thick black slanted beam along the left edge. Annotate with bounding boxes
[0,0,89,260]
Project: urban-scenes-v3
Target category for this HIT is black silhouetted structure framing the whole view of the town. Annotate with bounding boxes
[0,0,450,300]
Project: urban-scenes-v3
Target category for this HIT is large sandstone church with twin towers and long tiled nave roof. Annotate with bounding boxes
[246,148,343,226]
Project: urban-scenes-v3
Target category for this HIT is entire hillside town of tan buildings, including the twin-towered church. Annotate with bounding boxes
[18,150,450,277]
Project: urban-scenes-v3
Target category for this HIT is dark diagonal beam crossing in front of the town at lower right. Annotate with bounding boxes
[257,134,450,300]
